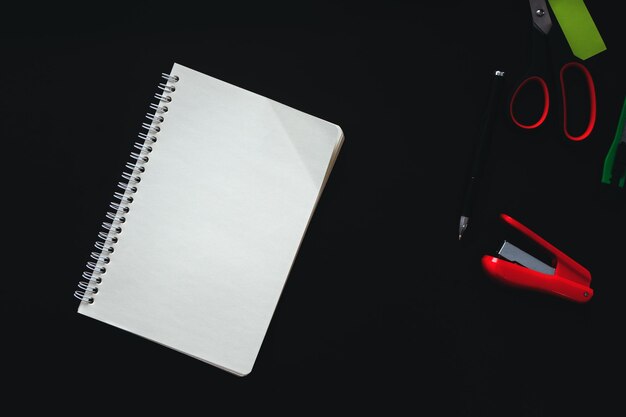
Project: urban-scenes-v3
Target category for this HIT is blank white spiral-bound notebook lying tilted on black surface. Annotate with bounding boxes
[74,64,343,376]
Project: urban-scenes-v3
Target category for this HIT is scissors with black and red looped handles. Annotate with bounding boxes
[509,0,596,141]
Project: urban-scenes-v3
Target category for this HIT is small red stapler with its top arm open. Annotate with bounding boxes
[482,214,593,303]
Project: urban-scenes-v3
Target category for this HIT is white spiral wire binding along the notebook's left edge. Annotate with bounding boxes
[74,73,179,304]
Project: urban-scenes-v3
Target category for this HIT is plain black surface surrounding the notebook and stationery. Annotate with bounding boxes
[0,1,626,416]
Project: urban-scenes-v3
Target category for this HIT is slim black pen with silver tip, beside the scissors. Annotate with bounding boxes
[459,71,504,240]
